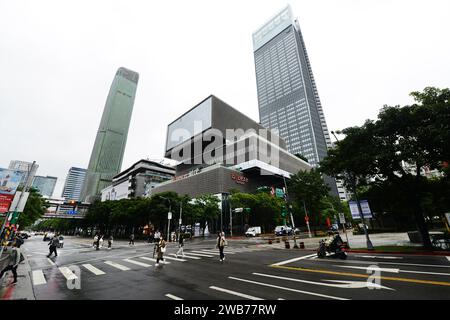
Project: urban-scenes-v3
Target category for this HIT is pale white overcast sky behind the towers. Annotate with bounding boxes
[0,0,450,196]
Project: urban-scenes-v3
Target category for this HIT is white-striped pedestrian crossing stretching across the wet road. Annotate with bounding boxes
[32,246,270,286]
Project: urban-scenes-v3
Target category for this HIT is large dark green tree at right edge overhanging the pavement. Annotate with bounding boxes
[321,87,450,248]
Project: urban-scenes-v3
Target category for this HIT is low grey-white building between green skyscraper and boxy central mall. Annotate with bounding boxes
[101,160,175,201]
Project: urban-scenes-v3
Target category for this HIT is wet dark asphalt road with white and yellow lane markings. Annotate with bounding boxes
[14,236,450,300]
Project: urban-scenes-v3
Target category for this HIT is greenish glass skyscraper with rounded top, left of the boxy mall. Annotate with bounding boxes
[82,68,139,202]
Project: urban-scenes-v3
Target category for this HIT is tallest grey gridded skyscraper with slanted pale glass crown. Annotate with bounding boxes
[253,6,338,196]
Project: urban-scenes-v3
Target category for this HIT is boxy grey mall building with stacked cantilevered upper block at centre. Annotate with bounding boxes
[153,96,311,198]
